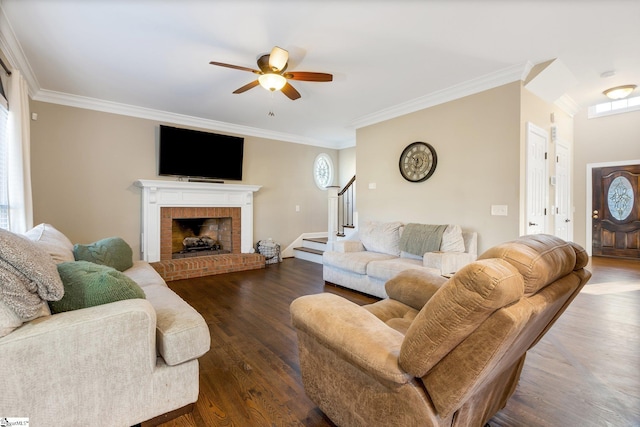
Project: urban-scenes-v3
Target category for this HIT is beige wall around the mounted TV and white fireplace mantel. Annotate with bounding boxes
[31,101,338,253]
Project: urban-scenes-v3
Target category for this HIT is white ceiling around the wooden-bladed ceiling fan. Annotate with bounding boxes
[0,0,640,148]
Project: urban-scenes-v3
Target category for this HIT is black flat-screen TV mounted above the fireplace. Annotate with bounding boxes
[158,125,244,181]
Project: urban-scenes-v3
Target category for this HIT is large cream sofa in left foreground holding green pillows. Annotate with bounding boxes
[0,224,210,426]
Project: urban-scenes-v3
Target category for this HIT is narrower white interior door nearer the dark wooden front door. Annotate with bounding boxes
[555,143,573,241]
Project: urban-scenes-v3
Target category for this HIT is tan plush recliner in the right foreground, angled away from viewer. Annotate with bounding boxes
[291,235,591,427]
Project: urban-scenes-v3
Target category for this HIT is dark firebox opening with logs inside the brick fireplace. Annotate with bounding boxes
[171,217,233,259]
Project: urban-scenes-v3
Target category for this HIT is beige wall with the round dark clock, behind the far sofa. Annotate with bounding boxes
[356,82,521,251]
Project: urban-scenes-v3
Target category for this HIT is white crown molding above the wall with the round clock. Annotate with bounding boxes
[351,61,533,129]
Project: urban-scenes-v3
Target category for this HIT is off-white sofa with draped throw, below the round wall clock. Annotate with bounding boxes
[322,221,478,298]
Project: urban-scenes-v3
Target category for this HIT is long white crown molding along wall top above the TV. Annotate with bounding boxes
[32,90,340,149]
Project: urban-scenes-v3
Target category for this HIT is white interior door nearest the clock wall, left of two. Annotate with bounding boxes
[525,123,549,234]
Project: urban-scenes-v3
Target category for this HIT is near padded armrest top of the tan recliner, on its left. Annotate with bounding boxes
[291,293,413,384]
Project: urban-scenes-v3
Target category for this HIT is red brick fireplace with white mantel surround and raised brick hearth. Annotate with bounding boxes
[135,180,265,281]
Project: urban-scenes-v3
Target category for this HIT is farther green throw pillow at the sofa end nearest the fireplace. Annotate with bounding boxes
[73,237,133,271]
